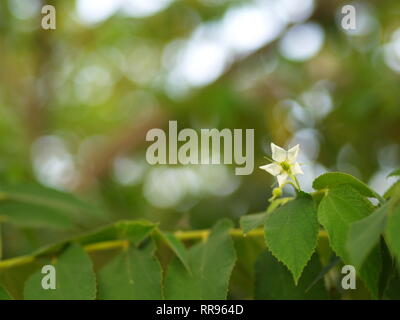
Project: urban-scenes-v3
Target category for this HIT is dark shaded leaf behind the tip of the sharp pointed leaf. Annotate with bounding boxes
[255,250,328,300]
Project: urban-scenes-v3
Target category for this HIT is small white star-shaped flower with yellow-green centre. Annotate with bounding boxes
[260,143,303,187]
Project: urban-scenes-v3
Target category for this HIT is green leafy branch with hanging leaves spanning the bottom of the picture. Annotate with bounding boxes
[0,172,400,300]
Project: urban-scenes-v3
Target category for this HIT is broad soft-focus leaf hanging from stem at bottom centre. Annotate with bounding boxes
[165,220,236,300]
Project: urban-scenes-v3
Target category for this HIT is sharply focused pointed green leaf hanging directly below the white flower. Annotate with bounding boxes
[265,193,318,283]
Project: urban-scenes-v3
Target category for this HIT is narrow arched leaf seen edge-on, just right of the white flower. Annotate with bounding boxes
[313,172,380,199]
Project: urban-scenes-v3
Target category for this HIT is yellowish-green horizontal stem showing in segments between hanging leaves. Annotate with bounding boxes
[0,228,327,271]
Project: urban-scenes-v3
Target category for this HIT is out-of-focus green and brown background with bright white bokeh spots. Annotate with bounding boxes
[0,0,400,256]
